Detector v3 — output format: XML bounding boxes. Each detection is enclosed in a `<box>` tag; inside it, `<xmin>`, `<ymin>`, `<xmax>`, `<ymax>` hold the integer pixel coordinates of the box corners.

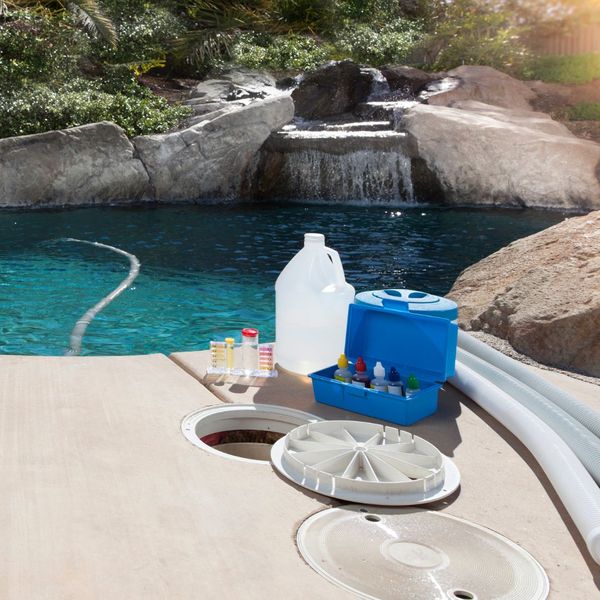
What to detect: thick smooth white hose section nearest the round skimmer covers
<box><xmin>449</xmin><ymin>361</ymin><xmax>600</xmax><ymax>564</ymax></box>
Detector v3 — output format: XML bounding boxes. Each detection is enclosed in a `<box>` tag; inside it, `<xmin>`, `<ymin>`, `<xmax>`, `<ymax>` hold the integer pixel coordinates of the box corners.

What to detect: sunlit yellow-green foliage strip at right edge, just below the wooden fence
<box><xmin>522</xmin><ymin>54</ymin><xmax>600</xmax><ymax>84</ymax></box>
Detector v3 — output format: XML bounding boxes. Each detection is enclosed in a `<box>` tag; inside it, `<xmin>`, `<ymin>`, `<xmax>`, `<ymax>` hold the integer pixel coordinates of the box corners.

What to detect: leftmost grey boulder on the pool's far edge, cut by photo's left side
<box><xmin>0</xmin><ymin>122</ymin><xmax>148</xmax><ymax>207</ymax></box>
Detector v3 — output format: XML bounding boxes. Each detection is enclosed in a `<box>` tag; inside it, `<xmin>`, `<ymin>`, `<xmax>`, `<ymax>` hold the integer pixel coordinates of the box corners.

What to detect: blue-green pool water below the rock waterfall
<box><xmin>0</xmin><ymin>205</ymin><xmax>564</xmax><ymax>355</ymax></box>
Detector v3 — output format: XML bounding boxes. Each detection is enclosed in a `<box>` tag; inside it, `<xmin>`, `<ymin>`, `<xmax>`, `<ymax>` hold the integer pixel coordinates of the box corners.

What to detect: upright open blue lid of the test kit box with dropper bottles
<box><xmin>345</xmin><ymin>303</ymin><xmax>458</xmax><ymax>382</ymax></box>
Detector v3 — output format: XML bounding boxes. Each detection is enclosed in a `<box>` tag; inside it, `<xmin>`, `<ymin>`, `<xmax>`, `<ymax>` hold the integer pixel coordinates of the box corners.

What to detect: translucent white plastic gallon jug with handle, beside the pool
<box><xmin>275</xmin><ymin>233</ymin><xmax>354</xmax><ymax>375</ymax></box>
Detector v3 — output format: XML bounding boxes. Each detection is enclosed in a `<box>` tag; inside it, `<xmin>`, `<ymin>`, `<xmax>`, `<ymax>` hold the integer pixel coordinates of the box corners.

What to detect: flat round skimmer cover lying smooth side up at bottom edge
<box><xmin>297</xmin><ymin>505</ymin><xmax>549</xmax><ymax>600</ymax></box>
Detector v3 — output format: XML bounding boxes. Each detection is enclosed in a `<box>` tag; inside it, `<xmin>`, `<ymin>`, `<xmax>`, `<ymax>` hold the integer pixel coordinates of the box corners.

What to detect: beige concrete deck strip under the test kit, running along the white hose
<box><xmin>171</xmin><ymin>352</ymin><xmax>600</xmax><ymax>600</ymax></box>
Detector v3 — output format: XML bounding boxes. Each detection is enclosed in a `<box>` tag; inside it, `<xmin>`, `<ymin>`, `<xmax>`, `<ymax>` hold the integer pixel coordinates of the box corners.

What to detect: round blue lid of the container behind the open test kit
<box><xmin>355</xmin><ymin>289</ymin><xmax>458</xmax><ymax>321</ymax></box>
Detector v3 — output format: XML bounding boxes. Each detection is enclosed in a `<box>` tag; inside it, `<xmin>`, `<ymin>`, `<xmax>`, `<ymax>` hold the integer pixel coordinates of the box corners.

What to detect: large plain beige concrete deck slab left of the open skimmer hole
<box><xmin>0</xmin><ymin>355</ymin><xmax>349</xmax><ymax>600</ymax></box>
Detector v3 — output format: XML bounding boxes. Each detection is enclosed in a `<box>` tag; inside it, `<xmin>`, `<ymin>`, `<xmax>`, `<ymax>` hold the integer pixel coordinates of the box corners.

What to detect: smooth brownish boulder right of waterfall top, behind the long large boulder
<box><xmin>421</xmin><ymin>65</ymin><xmax>536</xmax><ymax>110</ymax></box>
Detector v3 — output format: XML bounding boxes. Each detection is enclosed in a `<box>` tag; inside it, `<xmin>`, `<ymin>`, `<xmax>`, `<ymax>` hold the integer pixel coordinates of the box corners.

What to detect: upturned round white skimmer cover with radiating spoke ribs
<box><xmin>271</xmin><ymin>421</ymin><xmax>460</xmax><ymax>506</ymax></box>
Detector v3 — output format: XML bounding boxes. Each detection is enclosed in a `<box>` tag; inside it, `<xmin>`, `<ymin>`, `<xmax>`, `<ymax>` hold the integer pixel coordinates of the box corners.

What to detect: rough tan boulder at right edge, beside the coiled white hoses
<box><xmin>448</xmin><ymin>211</ymin><xmax>600</xmax><ymax>377</ymax></box>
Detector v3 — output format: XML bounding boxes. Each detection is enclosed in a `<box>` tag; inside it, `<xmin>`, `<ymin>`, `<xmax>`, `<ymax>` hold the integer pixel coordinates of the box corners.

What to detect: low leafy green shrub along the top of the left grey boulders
<box><xmin>0</xmin><ymin>79</ymin><xmax>191</xmax><ymax>137</ymax></box>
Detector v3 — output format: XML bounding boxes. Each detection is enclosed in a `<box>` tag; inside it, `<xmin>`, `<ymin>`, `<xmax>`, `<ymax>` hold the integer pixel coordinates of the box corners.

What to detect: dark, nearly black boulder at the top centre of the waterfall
<box><xmin>292</xmin><ymin>60</ymin><xmax>373</xmax><ymax>119</ymax></box>
